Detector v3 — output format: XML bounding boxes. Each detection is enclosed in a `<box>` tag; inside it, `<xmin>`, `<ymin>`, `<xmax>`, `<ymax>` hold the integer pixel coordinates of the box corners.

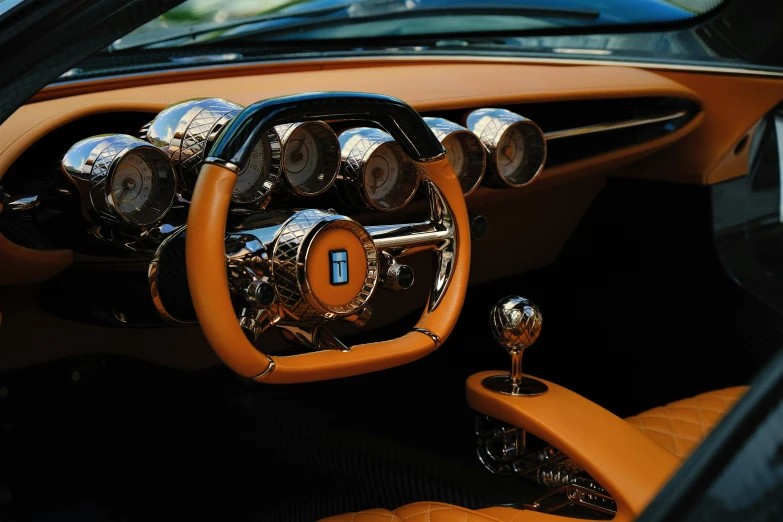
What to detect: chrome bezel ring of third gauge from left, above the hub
<box><xmin>275</xmin><ymin>121</ymin><xmax>340</xmax><ymax>196</ymax></box>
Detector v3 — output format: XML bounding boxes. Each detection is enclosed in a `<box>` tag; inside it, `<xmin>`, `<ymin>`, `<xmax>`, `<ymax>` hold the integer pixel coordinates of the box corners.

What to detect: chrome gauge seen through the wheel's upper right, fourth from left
<box><xmin>339</xmin><ymin>127</ymin><xmax>419</xmax><ymax>212</ymax></box>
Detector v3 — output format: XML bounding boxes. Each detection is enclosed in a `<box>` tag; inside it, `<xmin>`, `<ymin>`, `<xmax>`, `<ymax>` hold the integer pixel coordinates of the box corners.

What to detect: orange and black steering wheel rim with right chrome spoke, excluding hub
<box><xmin>186</xmin><ymin>93</ymin><xmax>470</xmax><ymax>383</ymax></box>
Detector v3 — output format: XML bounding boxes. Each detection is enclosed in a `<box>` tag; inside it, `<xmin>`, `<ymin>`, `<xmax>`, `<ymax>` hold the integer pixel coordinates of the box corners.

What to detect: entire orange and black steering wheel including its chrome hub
<box><xmin>186</xmin><ymin>93</ymin><xmax>470</xmax><ymax>383</ymax></box>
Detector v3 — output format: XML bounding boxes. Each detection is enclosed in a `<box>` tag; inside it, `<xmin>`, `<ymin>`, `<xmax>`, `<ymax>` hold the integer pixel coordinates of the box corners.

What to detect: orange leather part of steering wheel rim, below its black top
<box><xmin>186</xmin><ymin>158</ymin><xmax>470</xmax><ymax>383</ymax></box>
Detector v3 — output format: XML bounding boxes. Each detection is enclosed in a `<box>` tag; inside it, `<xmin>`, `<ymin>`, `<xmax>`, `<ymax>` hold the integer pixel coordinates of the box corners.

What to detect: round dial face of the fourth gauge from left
<box><xmin>363</xmin><ymin>142</ymin><xmax>418</xmax><ymax>210</ymax></box>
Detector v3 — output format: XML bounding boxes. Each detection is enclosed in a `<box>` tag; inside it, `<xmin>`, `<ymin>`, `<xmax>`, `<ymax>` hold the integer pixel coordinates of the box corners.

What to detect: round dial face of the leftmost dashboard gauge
<box><xmin>111</xmin><ymin>152</ymin><xmax>156</xmax><ymax>218</ymax></box>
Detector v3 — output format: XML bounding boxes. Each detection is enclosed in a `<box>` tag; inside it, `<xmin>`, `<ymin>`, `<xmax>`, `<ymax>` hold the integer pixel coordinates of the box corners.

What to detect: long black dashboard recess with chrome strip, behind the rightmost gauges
<box><xmin>425</xmin><ymin>97</ymin><xmax>701</xmax><ymax>167</ymax></box>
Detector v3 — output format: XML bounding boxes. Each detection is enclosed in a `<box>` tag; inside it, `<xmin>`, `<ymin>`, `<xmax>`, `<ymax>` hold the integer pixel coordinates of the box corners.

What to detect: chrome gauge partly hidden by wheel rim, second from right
<box><xmin>424</xmin><ymin>118</ymin><xmax>487</xmax><ymax>196</ymax></box>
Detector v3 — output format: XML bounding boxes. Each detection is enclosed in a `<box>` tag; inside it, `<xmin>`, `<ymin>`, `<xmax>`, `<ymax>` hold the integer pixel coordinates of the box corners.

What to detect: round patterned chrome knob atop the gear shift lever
<box><xmin>489</xmin><ymin>295</ymin><xmax>542</xmax><ymax>354</ymax></box>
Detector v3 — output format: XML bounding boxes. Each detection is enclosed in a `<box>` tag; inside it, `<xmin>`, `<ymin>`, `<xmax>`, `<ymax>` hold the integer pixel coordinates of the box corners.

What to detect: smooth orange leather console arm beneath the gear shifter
<box><xmin>466</xmin><ymin>372</ymin><xmax>681</xmax><ymax>522</ymax></box>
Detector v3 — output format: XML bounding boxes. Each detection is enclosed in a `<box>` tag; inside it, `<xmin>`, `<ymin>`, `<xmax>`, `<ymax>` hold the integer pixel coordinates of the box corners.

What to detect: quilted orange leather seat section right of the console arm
<box><xmin>626</xmin><ymin>386</ymin><xmax>748</xmax><ymax>459</ymax></box>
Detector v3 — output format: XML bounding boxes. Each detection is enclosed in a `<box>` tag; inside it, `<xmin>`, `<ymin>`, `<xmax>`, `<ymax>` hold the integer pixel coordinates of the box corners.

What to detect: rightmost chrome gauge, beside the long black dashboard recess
<box><xmin>467</xmin><ymin>109</ymin><xmax>546</xmax><ymax>188</ymax></box>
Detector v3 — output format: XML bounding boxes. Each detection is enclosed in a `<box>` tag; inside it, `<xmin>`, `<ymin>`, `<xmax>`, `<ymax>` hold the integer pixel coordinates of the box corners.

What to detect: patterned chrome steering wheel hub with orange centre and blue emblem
<box><xmin>272</xmin><ymin>210</ymin><xmax>378</xmax><ymax>321</ymax></box>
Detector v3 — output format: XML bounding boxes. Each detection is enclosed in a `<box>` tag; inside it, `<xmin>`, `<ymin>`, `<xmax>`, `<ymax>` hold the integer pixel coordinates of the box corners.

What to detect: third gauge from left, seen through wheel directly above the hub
<box><xmin>275</xmin><ymin>121</ymin><xmax>340</xmax><ymax>196</ymax></box>
